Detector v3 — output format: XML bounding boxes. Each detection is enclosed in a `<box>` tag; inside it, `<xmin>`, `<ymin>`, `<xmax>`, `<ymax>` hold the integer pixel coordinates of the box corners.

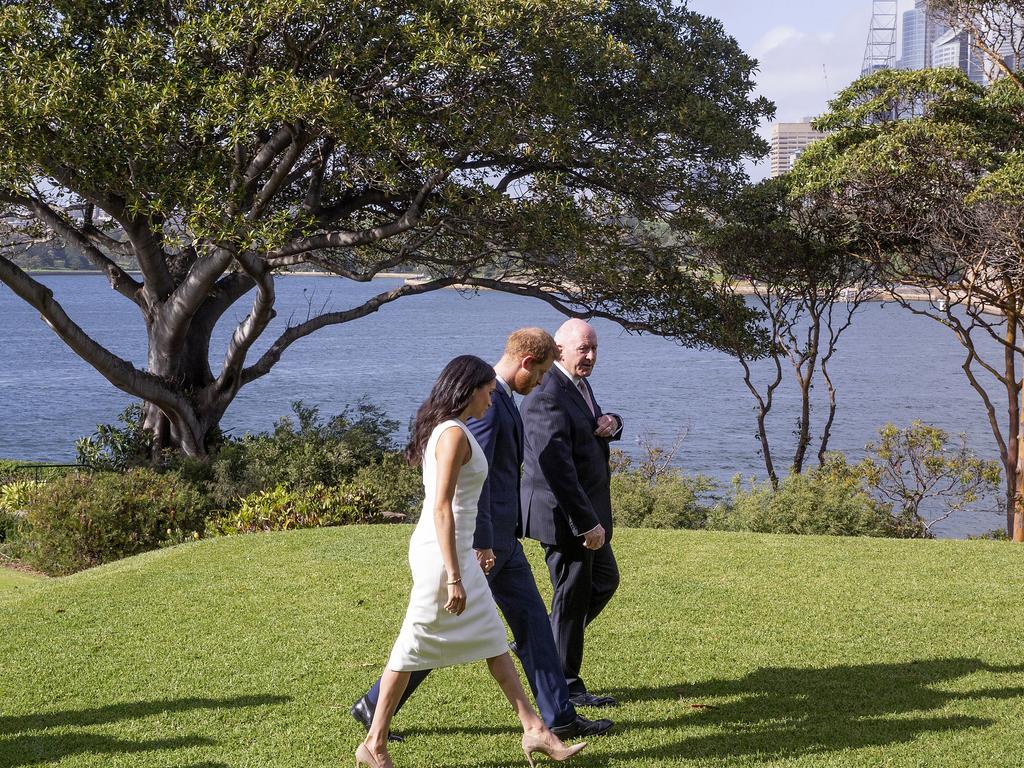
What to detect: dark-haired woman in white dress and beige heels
<box><xmin>355</xmin><ymin>355</ymin><xmax>586</xmax><ymax>768</ymax></box>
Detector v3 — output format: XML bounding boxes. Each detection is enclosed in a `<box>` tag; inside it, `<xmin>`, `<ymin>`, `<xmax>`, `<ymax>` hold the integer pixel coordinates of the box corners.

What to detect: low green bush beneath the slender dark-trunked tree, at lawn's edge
<box><xmin>708</xmin><ymin>457</ymin><xmax>901</xmax><ymax>537</ymax></box>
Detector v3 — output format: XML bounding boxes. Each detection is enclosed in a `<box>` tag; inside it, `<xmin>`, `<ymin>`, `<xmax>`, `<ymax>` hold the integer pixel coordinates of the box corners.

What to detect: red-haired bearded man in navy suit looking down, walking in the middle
<box><xmin>351</xmin><ymin>328</ymin><xmax>612</xmax><ymax>739</ymax></box>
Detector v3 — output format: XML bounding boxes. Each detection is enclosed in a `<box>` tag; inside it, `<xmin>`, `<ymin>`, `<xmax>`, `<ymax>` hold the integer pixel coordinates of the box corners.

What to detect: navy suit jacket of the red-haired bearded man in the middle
<box><xmin>466</xmin><ymin>384</ymin><xmax>522</xmax><ymax>550</ymax></box>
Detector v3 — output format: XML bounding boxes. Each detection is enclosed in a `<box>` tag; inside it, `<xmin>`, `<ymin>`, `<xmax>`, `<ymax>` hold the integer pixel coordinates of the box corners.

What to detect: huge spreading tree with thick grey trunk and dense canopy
<box><xmin>0</xmin><ymin>0</ymin><xmax>771</xmax><ymax>455</ymax></box>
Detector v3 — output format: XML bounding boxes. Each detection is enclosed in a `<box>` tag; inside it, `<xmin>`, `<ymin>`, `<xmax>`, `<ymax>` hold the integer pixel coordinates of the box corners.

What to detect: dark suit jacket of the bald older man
<box><xmin>522</xmin><ymin>368</ymin><xmax>622</xmax><ymax>546</ymax></box>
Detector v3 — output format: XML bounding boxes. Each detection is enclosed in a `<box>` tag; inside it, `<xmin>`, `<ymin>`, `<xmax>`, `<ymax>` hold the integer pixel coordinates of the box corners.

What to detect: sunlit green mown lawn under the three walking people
<box><xmin>0</xmin><ymin>526</ymin><xmax>1024</xmax><ymax>768</ymax></box>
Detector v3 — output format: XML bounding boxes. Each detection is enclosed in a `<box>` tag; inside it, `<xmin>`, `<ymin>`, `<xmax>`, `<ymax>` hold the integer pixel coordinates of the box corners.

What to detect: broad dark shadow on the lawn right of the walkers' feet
<box><xmin>466</xmin><ymin>658</ymin><xmax>1024</xmax><ymax>765</ymax></box>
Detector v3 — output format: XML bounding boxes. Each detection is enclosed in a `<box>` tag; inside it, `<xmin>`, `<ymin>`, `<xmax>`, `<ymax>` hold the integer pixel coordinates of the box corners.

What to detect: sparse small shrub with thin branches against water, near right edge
<box><xmin>855</xmin><ymin>421</ymin><xmax>1002</xmax><ymax>532</ymax></box>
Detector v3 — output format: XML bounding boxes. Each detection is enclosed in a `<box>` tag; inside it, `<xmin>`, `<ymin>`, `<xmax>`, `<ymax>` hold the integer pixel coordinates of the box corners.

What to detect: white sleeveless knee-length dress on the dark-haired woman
<box><xmin>387</xmin><ymin>419</ymin><xmax>509</xmax><ymax>672</ymax></box>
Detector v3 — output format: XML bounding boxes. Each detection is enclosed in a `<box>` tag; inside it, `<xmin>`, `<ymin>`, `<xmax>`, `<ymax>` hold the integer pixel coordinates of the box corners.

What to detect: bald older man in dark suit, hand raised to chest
<box><xmin>522</xmin><ymin>319</ymin><xmax>623</xmax><ymax>707</ymax></box>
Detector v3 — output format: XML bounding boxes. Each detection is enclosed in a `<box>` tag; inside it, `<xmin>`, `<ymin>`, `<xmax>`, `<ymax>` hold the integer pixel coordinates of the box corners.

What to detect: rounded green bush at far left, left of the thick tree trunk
<box><xmin>17</xmin><ymin>469</ymin><xmax>206</xmax><ymax>575</ymax></box>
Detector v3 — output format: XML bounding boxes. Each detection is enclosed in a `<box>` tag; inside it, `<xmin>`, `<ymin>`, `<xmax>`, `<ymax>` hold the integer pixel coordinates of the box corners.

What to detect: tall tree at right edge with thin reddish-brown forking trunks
<box><xmin>793</xmin><ymin>70</ymin><xmax>1024</xmax><ymax>541</ymax></box>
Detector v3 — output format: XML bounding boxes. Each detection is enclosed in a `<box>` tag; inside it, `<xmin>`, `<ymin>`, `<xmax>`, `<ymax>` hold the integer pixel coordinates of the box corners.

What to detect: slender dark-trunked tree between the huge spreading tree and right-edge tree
<box><xmin>694</xmin><ymin>176</ymin><xmax>876</xmax><ymax>486</ymax></box>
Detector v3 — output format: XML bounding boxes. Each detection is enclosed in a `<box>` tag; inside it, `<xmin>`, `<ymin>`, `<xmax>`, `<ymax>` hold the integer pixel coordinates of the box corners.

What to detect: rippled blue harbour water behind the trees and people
<box><xmin>0</xmin><ymin>274</ymin><xmax>1005</xmax><ymax>537</ymax></box>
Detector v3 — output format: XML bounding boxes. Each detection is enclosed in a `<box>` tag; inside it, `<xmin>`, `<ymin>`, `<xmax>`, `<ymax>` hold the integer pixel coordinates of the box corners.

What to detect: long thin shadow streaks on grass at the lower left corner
<box><xmin>0</xmin><ymin>695</ymin><xmax>291</xmax><ymax>768</ymax></box>
